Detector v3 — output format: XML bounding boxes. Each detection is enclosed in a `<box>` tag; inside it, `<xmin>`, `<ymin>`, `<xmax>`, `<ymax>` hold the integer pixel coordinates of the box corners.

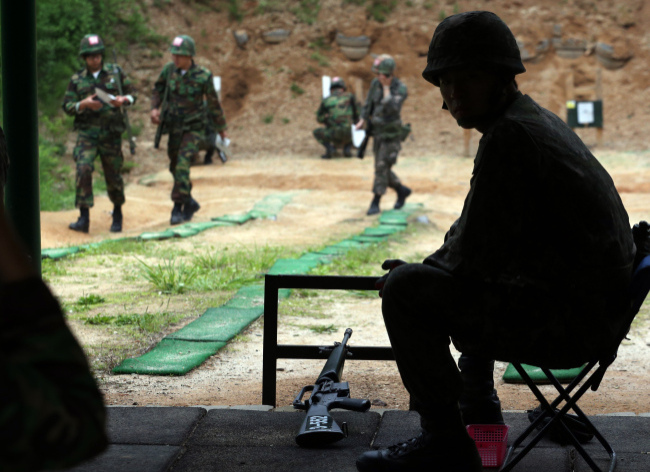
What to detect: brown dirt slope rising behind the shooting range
<box><xmin>110</xmin><ymin>0</ymin><xmax>650</xmax><ymax>175</ymax></box>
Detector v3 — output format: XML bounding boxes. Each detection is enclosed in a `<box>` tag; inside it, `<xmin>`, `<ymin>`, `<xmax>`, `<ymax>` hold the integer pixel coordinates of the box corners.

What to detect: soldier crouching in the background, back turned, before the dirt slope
<box><xmin>314</xmin><ymin>77</ymin><xmax>359</xmax><ymax>159</ymax></box>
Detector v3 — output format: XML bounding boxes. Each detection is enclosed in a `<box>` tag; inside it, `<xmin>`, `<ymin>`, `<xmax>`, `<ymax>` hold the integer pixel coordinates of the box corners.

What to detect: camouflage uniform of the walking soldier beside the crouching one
<box><xmin>361</xmin><ymin>77</ymin><xmax>408</xmax><ymax>195</ymax></box>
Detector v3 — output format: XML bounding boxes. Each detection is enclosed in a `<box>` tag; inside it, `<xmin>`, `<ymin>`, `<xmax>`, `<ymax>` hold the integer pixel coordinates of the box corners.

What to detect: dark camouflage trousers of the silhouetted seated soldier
<box><xmin>382</xmin><ymin>264</ymin><xmax>629</xmax><ymax>421</ymax></box>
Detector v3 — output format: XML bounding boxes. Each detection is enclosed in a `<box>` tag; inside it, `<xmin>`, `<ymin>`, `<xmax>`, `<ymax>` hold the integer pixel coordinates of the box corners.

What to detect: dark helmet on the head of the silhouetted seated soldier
<box><xmin>422</xmin><ymin>11</ymin><xmax>526</xmax><ymax>87</ymax></box>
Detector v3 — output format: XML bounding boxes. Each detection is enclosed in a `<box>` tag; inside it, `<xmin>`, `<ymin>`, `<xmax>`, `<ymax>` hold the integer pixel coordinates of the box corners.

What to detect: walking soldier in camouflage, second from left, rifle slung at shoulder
<box><xmin>151</xmin><ymin>35</ymin><xmax>227</xmax><ymax>225</ymax></box>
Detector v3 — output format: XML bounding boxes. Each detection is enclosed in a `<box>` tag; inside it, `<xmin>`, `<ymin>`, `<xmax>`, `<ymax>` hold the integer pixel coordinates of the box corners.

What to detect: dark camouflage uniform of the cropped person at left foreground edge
<box><xmin>0</xmin><ymin>277</ymin><xmax>108</xmax><ymax>471</ymax></box>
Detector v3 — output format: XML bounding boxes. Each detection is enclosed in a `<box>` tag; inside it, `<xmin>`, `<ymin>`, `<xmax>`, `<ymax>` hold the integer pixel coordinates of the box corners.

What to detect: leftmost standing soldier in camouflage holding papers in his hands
<box><xmin>63</xmin><ymin>34</ymin><xmax>136</xmax><ymax>233</ymax></box>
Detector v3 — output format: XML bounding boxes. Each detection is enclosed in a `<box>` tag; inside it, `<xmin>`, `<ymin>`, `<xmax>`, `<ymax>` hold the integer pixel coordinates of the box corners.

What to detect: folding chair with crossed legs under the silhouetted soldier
<box><xmin>500</xmin><ymin>256</ymin><xmax>650</xmax><ymax>472</ymax></box>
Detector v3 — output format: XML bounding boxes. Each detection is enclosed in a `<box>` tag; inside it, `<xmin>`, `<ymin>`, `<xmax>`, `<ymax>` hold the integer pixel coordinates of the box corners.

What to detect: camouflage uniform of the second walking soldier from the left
<box><xmin>151</xmin><ymin>62</ymin><xmax>226</xmax><ymax>203</ymax></box>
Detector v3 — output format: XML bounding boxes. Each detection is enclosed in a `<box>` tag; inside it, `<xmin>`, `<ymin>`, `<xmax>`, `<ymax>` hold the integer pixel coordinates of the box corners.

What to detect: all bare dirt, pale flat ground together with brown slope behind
<box><xmin>41</xmin><ymin>0</ymin><xmax>650</xmax><ymax>413</ymax></box>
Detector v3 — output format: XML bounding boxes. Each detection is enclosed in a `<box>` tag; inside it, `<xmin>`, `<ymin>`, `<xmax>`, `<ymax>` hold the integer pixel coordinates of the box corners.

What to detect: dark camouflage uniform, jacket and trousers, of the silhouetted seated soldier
<box><xmin>383</xmin><ymin>93</ymin><xmax>635</xmax><ymax>419</ymax></box>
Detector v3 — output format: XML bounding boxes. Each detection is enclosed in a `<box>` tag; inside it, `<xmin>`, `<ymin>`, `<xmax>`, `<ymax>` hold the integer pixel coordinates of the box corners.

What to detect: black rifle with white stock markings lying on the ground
<box><xmin>293</xmin><ymin>328</ymin><xmax>370</xmax><ymax>447</ymax></box>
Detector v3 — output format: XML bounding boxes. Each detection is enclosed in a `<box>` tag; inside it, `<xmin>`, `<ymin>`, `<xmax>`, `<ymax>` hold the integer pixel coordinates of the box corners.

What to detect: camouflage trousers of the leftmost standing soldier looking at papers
<box><xmin>73</xmin><ymin>127</ymin><xmax>124</xmax><ymax>208</ymax></box>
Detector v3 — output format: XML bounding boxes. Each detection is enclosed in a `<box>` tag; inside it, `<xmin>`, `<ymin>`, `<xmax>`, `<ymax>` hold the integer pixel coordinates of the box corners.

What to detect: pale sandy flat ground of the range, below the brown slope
<box><xmin>42</xmin><ymin>149</ymin><xmax>650</xmax><ymax>412</ymax></box>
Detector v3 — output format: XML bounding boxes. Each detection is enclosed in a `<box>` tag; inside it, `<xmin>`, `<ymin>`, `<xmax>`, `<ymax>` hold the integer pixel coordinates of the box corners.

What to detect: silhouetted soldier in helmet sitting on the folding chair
<box><xmin>357</xmin><ymin>11</ymin><xmax>635</xmax><ymax>472</ymax></box>
